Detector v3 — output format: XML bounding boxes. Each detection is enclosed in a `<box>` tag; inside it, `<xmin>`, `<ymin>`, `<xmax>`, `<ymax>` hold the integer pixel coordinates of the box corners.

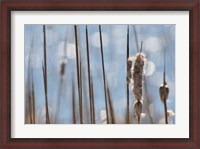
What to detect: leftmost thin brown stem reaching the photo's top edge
<box><xmin>43</xmin><ymin>25</ymin><xmax>50</xmax><ymax>124</ymax></box>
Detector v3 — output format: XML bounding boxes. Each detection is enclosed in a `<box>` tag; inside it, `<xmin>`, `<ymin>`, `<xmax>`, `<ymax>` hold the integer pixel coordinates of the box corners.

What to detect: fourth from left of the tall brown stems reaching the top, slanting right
<box><xmin>99</xmin><ymin>25</ymin><xmax>109</xmax><ymax>124</ymax></box>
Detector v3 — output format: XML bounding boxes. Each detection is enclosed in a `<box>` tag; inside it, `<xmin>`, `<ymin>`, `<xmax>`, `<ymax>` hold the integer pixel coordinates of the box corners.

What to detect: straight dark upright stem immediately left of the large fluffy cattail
<box><xmin>126</xmin><ymin>25</ymin><xmax>130</xmax><ymax>124</ymax></box>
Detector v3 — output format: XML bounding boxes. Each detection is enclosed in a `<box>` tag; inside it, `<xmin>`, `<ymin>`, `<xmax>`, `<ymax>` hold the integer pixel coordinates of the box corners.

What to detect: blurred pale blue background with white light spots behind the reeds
<box><xmin>24</xmin><ymin>24</ymin><xmax>175</xmax><ymax>124</ymax></box>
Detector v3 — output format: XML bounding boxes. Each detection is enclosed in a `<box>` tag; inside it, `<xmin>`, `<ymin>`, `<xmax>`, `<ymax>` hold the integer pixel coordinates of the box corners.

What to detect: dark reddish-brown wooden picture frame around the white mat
<box><xmin>0</xmin><ymin>0</ymin><xmax>200</xmax><ymax>149</ymax></box>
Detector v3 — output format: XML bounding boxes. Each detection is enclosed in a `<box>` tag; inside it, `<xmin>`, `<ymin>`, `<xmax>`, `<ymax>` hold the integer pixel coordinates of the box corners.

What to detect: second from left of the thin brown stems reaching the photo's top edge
<box><xmin>74</xmin><ymin>25</ymin><xmax>83</xmax><ymax>124</ymax></box>
